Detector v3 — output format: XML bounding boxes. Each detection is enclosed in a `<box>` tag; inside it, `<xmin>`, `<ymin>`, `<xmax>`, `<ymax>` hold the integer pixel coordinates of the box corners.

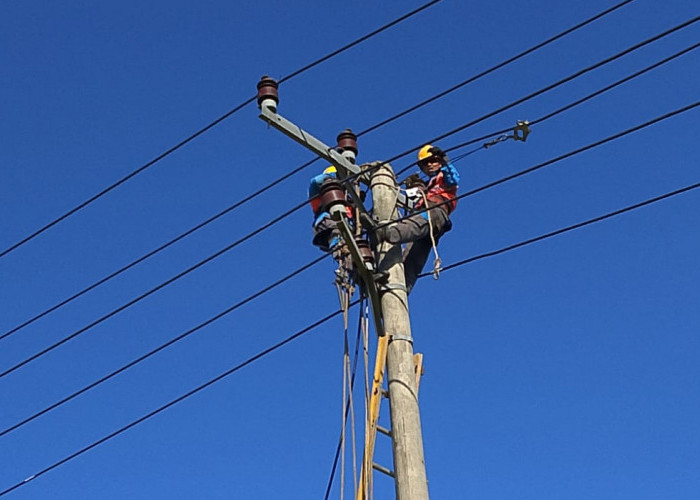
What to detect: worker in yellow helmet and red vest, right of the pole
<box><xmin>374</xmin><ymin>144</ymin><xmax>459</xmax><ymax>293</ymax></box>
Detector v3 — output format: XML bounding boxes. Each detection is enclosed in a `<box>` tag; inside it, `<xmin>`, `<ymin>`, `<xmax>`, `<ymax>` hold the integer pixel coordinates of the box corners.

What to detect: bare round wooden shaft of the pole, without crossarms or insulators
<box><xmin>370</xmin><ymin>164</ymin><xmax>428</xmax><ymax>500</ymax></box>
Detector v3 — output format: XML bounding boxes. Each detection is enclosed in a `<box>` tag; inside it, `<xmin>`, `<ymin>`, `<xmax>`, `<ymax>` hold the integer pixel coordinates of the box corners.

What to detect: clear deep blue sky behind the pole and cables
<box><xmin>0</xmin><ymin>0</ymin><xmax>700</xmax><ymax>500</ymax></box>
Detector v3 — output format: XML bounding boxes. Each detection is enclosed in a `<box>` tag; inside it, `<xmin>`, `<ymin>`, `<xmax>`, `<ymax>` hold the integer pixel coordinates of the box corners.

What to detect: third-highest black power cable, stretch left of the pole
<box><xmin>0</xmin><ymin>201</ymin><xmax>308</xmax><ymax>378</ymax></box>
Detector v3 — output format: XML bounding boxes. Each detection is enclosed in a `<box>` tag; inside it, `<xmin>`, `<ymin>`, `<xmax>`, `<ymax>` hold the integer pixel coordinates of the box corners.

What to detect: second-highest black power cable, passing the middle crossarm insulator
<box><xmin>0</xmin><ymin>0</ymin><xmax>634</xmax><ymax>340</ymax></box>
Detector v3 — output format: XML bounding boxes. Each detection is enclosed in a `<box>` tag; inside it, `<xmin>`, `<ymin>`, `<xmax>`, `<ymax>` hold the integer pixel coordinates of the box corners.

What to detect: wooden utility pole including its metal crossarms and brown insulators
<box><xmin>258</xmin><ymin>76</ymin><xmax>428</xmax><ymax>500</ymax></box>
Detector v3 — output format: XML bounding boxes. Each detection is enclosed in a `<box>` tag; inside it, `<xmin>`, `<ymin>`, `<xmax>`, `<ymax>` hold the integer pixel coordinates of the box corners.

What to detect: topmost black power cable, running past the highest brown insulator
<box><xmin>0</xmin><ymin>0</ymin><xmax>440</xmax><ymax>258</ymax></box>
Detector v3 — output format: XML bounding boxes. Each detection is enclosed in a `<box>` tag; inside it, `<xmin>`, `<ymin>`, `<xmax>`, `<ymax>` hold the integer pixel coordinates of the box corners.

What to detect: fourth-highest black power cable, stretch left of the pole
<box><xmin>0</xmin><ymin>254</ymin><xmax>330</xmax><ymax>437</ymax></box>
